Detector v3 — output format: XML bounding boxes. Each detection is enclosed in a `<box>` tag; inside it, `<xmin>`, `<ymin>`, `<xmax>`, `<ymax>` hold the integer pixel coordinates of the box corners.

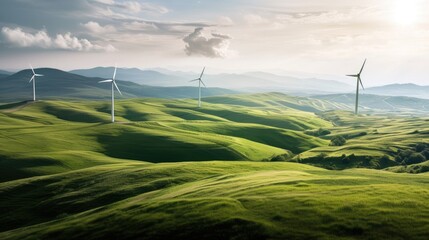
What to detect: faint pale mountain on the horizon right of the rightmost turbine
<box><xmin>364</xmin><ymin>83</ymin><xmax>429</xmax><ymax>99</ymax></box>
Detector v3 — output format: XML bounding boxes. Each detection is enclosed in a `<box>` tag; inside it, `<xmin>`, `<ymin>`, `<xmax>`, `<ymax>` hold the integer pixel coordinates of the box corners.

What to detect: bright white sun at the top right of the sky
<box><xmin>393</xmin><ymin>0</ymin><xmax>418</xmax><ymax>26</ymax></box>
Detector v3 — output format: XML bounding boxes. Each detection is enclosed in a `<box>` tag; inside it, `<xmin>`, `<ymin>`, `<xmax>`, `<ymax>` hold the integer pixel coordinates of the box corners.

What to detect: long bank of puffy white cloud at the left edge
<box><xmin>1</xmin><ymin>27</ymin><xmax>116</xmax><ymax>52</ymax></box>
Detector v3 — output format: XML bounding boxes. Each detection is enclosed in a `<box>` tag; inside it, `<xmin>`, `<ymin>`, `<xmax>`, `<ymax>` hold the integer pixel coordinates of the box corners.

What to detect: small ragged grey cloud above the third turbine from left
<box><xmin>183</xmin><ymin>28</ymin><xmax>231</xmax><ymax>58</ymax></box>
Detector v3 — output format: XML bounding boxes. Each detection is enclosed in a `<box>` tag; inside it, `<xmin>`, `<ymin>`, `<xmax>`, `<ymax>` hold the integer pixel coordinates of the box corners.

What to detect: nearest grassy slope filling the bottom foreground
<box><xmin>0</xmin><ymin>162</ymin><xmax>429</xmax><ymax>239</ymax></box>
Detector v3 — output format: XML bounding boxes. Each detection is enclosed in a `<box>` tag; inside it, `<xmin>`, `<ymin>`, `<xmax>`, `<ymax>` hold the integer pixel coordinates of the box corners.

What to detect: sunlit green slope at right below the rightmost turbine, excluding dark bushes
<box><xmin>299</xmin><ymin>111</ymin><xmax>429</xmax><ymax>168</ymax></box>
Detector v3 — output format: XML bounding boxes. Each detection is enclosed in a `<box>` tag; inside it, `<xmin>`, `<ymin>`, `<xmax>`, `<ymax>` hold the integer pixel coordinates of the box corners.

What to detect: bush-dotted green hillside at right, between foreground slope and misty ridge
<box><xmin>294</xmin><ymin>111</ymin><xmax>429</xmax><ymax>169</ymax></box>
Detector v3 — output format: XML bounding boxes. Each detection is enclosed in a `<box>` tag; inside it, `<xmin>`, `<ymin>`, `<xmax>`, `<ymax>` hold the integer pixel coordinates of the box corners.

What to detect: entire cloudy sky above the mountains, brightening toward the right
<box><xmin>0</xmin><ymin>0</ymin><xmax>429</xmax><ymax>86</ymax></box>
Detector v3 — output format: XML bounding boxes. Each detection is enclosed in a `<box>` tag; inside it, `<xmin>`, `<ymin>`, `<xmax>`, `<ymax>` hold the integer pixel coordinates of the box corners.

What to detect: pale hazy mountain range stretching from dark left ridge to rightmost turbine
<box><xmin>71</xmin><ymin>67</ymin><xmax>353</xmax><ymax>95</ymax></box>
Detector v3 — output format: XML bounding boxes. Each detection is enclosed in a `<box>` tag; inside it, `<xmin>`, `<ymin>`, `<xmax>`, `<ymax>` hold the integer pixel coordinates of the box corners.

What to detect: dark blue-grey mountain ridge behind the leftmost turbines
<box><xmin>0</xmin><ymin>68</ymin><xmax>236</xmax><ymax>102</ymax></box>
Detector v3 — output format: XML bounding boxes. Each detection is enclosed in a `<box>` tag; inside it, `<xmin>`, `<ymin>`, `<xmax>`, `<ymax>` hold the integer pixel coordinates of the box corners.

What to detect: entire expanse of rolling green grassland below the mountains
<box><xmin>0</xmin><ymin>94</ymin><xmax>429</xmax><ymax>239</ymax></box>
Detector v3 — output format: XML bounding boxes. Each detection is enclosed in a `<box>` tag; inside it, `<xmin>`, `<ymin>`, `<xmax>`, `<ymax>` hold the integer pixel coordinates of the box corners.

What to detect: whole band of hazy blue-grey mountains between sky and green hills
<box><xmin>0</xmin><ymin>67</ymin><xmax>429</xmax><ymax>113</ymax></box>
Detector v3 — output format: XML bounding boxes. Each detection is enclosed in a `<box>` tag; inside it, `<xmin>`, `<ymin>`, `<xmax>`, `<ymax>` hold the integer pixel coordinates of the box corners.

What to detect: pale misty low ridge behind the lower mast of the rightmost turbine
<box><xmin>312</xmin><ymin>94</ymin><xmax>429</xmax><ymax>114</ymax></box>
